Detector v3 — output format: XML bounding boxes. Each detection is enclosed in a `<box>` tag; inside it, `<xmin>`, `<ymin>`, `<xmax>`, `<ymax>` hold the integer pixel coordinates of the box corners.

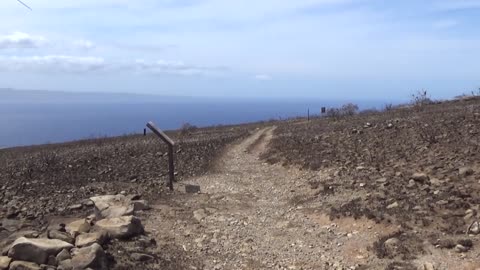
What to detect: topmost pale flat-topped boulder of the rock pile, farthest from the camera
<box><xmin>90</xmin><ymin>194</ymin><xmax>134</xmax><ymax>219</ymax></box>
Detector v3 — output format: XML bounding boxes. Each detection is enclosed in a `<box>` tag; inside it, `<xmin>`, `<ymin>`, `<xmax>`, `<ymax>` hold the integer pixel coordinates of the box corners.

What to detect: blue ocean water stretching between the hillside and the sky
<box><xmin>0</xmin><ymin>100</ymin><xmax>385</xmax><ymax>148</ymax></box>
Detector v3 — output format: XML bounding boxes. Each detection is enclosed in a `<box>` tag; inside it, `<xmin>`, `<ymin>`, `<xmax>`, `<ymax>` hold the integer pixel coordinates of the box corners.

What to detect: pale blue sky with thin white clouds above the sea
<box><xmin>0</xmin><ymin>0</ymin><xmax>480</xmax><ymax>100</ymax></box>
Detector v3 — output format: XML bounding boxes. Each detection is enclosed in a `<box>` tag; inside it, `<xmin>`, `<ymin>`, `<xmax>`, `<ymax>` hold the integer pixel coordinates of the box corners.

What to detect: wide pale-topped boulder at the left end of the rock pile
<box><xmin>8</xmin><ymin>237</ymin><xmax>73</xmax><ymax>264</ymax></box>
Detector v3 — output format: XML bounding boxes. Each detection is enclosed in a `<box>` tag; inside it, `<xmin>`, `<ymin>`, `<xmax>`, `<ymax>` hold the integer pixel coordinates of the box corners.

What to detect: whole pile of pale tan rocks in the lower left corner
<box><xmin>0</xmin><ymin>195</ymin><xmax>149</xmax><ymax>270</ymax></box>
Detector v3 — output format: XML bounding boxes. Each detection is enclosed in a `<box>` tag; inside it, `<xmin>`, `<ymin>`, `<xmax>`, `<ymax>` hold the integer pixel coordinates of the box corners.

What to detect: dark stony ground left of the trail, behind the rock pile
<box><xmin>0</xmin><ymin>126</ymin><xmax>251</xmax><ymax>240</ymax></box>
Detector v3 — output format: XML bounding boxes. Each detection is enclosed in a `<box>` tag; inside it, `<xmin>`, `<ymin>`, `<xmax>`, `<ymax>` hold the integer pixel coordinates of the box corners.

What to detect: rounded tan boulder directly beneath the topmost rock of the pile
<box><xmin>95</xmin><ymin>216</ymin><xmax>144</xmax><ymax>239</ymax></box>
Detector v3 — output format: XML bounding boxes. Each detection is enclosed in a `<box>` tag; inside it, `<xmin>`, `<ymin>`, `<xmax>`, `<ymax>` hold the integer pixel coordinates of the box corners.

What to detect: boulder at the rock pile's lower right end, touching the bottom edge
<box><xmin>72</xmin><ymin>243</ymin><xmax>108</xmax><ymax>270</ymax></box>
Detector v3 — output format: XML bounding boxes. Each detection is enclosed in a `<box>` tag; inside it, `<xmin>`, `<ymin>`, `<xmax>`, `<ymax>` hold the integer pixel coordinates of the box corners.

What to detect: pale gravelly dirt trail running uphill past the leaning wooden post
<box><xmin>142</xmin><ymin>127</ymin><xmax>408</xmax><ymax>269</ymax></box>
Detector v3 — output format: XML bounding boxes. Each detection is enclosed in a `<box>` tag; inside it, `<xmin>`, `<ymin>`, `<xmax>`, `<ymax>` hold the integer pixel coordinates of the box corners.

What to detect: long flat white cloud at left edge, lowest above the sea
<box><xmin>0</xmin><ymin>55</ymin><xmax>107</xmax><ymax>73</ymax></box>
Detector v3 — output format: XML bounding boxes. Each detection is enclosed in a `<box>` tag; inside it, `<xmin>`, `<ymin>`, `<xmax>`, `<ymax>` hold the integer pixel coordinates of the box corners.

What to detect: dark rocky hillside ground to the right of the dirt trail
<box><xmin>262</xmin><ymin>98</ymin><xmax>480</xmax><ymax>269</ymax></box>
